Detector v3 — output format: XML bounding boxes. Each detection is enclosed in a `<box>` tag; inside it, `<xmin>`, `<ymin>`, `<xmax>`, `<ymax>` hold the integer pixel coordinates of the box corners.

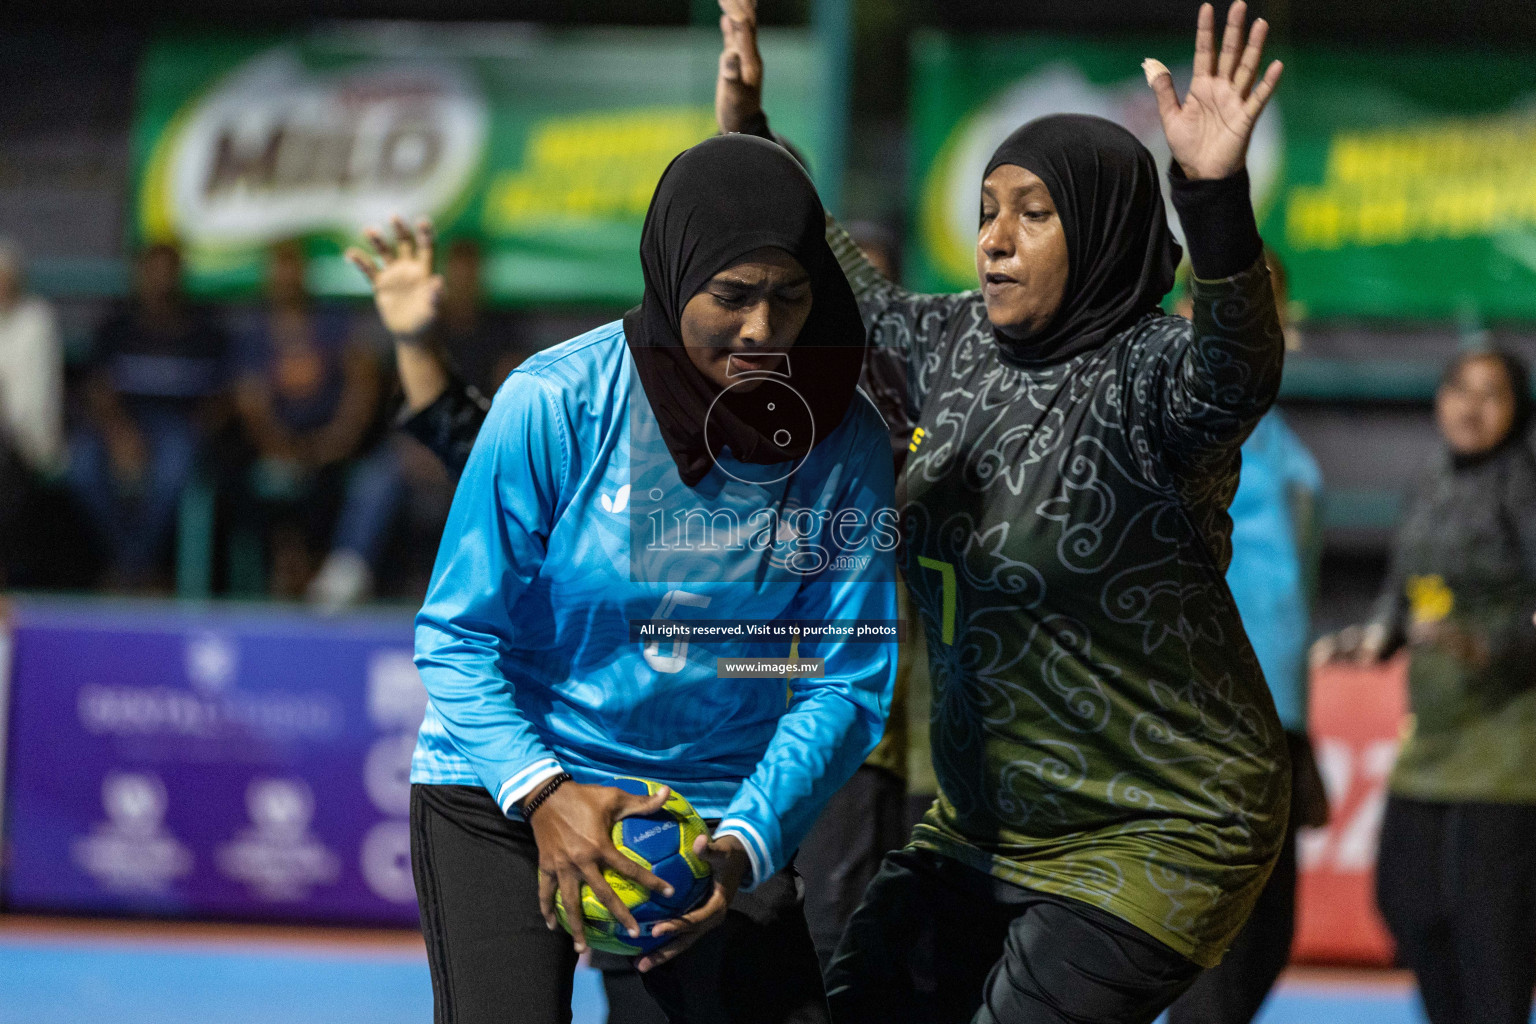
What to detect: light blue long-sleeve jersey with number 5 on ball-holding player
<box><xmin>410</xmin><ymin>322</ymin><xmax>895</xmax><ymax>884</ymax></box>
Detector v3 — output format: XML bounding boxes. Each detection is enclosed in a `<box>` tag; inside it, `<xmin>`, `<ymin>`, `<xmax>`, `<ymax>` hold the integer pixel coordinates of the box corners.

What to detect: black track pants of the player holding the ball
<box><xmin>410</xmin><ymin>785</ymin><xmax>828</xmax><ymax>1024</ymax></box>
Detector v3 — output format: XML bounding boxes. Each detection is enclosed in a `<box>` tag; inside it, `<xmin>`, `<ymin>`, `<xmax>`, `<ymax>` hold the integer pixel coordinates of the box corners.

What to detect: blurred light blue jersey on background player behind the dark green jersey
<box><xmin>1227</xmin><ymin>410</ymin><xmax>1322</xmax><ymax>731</ymax></box>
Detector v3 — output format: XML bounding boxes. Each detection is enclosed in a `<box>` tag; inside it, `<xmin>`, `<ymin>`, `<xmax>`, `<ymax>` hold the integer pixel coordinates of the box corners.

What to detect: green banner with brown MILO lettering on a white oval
<box><xmin>132</xmin><ymin>25</ymin><xmax>828</xmax><ymax>304</ymax></box>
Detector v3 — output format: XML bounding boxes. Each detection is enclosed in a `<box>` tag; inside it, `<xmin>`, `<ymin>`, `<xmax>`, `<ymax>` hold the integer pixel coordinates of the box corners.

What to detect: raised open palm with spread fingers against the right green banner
<box><xmin>1141</xmin><ymin>0</ymin><xmax>1283</xmax><ymax>178</ymax></box>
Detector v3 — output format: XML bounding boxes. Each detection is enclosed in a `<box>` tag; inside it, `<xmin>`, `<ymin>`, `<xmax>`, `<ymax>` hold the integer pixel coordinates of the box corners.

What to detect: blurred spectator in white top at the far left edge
<box><xmin>0</xmin><ymin>239</ymin><xmax>65</xmax><ymax>586</ymax></box>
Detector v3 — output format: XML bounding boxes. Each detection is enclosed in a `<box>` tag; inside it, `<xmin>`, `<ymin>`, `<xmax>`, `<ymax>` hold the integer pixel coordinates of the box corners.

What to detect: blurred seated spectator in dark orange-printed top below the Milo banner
<box><xmin>237</xmin><ymin>241</ymin><xmax>398</xmax><ymax>597</ymax></box>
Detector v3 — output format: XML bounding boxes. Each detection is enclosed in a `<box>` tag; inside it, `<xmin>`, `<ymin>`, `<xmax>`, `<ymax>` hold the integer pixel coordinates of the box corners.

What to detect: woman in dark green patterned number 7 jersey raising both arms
<box><xmin>717</xmin><ymin>0</ymin><xmax>1289</xmax><ymax>1024</ymax></box>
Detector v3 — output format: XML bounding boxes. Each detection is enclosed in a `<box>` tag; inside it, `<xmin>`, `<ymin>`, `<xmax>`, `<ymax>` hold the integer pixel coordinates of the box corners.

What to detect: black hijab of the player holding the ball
<box><xmin>624</xmin><ymin>135</ymin><xmax>865</xmax><ymax>487</ymax></box>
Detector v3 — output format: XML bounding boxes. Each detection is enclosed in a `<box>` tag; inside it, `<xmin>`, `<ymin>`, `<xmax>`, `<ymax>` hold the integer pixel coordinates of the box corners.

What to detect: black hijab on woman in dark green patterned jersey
<box><xmin>982</xmin><ymin>114</ymin><xmax>1183</xmax><ymax>364</ymax></box>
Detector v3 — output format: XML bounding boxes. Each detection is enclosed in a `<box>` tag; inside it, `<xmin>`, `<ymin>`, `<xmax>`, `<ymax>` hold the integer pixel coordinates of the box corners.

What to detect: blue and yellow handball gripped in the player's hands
<box><xmin>554</xmin><ymin>777</ymin><xmax>710</xmax><ymax>956</ymax></box>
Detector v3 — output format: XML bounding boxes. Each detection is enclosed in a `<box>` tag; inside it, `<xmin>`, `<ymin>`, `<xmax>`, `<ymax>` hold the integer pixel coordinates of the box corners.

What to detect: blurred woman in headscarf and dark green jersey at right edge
<box><xmin>1313</xmin><ymin>350</ymin><xmax>1536</xmax><ymax>1024</ymax></box>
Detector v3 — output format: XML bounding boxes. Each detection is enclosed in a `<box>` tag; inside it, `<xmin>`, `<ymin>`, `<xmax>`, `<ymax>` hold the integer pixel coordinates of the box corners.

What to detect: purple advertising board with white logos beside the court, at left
<box><xmin>0</xmin><ymin>602</ymin><xmax>427</xmax><ymax>926</ymax></box>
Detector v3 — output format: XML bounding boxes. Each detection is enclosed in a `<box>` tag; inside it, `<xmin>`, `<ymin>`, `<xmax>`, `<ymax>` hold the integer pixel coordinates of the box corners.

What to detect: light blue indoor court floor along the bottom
<box><xmin>0</xmin><ymin>917</ymin><xmax>1492</xmax><ymax>1024</ymax></box>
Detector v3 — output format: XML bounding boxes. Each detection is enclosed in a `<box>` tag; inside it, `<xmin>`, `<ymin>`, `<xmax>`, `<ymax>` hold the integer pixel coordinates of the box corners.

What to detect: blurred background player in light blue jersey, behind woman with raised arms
<box><xmin>1167</xmin><ymin>249</ymin><xmax>1327</xmax><ymax>1024</ymax></box>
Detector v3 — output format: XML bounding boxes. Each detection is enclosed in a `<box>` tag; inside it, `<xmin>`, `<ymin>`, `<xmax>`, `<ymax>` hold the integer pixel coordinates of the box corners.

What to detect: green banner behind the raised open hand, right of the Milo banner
<box><xmin>903</xmin><ymin>34</ymin><xmax>1536</xmax><ymax>321</ymax></box>
